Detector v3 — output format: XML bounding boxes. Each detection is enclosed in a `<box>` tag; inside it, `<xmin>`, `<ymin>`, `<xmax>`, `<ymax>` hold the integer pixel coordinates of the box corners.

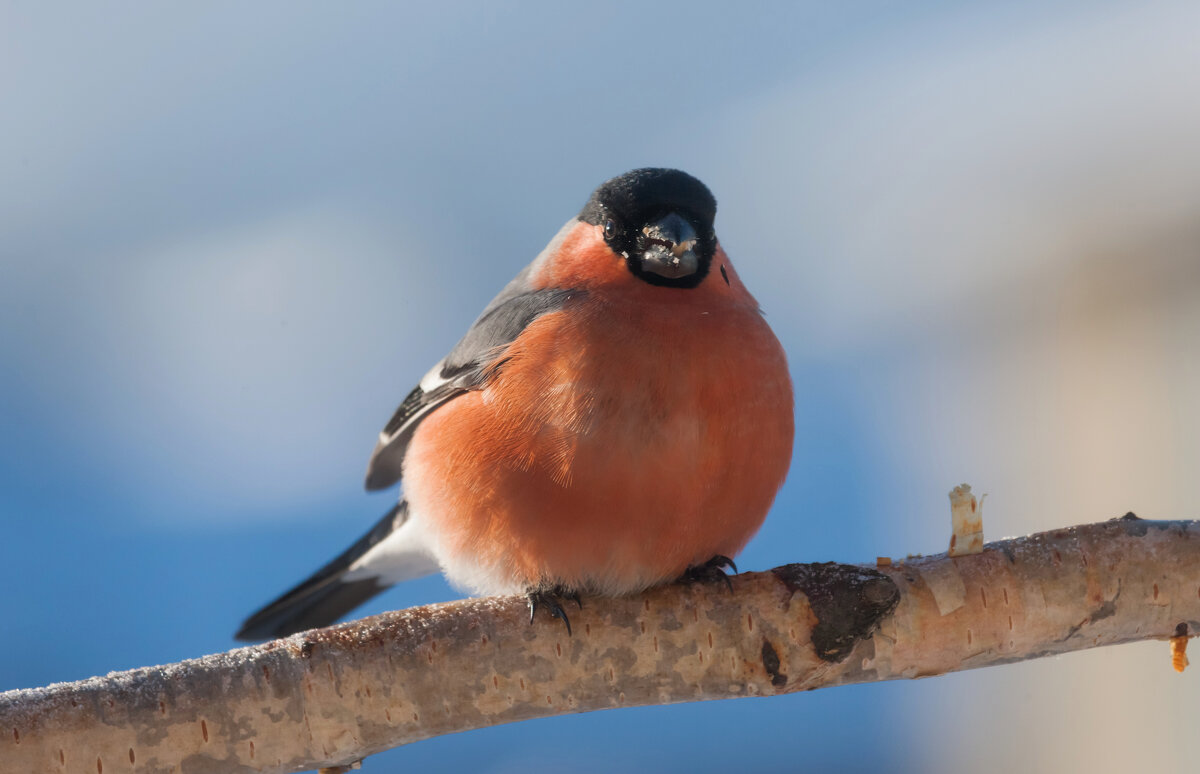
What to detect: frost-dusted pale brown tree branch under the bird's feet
<box><xmin>0</xmin><ymin>515</ymin><xmax>1200</xmax><ymax>774</ymax></box>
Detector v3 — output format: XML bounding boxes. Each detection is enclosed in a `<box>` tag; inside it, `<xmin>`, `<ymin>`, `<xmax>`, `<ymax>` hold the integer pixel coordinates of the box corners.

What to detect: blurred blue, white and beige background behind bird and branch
<box><xmin>0</xmin><ymin>0</ymin><xmax>1200</xmax><ymax>774</ymax></box>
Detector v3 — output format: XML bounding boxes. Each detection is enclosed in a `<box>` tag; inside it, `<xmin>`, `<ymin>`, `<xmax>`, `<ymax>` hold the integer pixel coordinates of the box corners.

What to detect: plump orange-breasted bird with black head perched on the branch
<box><xmin>235</xmin><ymin>168</ymin><xmax>794</xmax><ymax>641</ymax></box>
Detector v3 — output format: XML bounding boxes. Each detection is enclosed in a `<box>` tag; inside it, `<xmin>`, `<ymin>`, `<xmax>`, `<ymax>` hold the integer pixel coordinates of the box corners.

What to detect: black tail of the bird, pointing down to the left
<box><xmin>234</xmin><ymin>500</ymin><xmax>408</xmax><ymax>642</ymax></box>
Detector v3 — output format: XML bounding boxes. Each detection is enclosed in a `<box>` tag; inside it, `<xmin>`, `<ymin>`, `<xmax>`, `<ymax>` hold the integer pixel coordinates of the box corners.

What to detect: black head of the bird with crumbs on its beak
<box><xmin>580</xmin><ymin>168</ymin><xmax>716</xmax><ymax>288</ymax></box>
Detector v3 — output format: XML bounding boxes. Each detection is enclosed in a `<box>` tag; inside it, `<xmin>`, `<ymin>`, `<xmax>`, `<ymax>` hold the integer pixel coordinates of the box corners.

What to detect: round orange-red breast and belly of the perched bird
<box><xmin>404</xmin><ymin>254</ymin><xmax>792</xmax><ymax>594</ymax></box>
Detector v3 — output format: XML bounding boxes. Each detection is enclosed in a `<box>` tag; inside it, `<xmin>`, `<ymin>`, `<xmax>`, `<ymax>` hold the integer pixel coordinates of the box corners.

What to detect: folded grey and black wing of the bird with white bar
<box><xmin>366</xmin><ymin>262</ymin><xmax>582</xmax><ymax>492</ymax></box>
